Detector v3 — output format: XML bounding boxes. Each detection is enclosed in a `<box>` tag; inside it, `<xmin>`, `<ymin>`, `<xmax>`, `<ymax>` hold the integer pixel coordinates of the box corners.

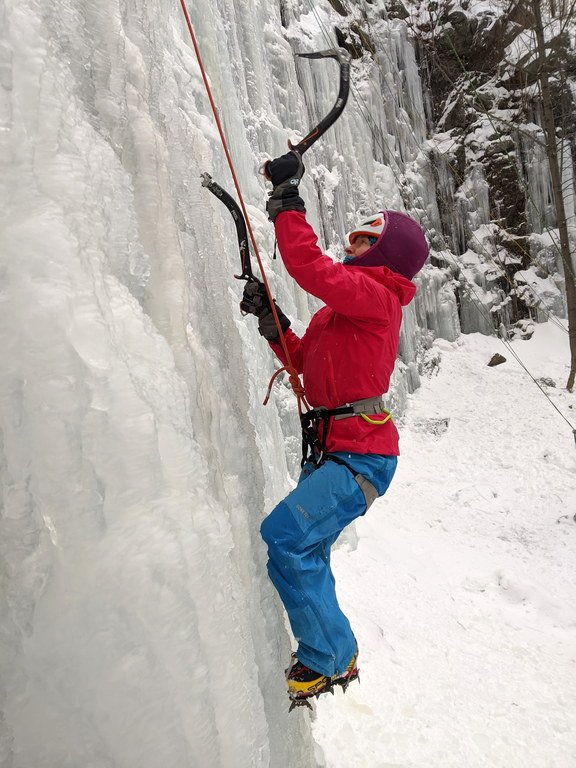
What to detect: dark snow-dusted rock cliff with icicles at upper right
<box><xmin>332</xmin><ymin>0</ymin><xmax>576</xmax><ymax>333</ymax></box>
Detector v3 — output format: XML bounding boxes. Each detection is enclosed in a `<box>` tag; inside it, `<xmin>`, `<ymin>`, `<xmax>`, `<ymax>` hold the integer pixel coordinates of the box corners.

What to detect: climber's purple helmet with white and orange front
<box><xmin>346</xmin><ymin>211</ymin><xmax>428</xmax><ymax>280</ymax></box>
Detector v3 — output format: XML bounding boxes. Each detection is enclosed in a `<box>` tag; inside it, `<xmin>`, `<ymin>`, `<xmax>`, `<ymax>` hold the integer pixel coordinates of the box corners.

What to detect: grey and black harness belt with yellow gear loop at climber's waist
<box><xmin>300</xmin><ymin>395</ymin><xmax>392</xmax><ymax>471</ymax></box>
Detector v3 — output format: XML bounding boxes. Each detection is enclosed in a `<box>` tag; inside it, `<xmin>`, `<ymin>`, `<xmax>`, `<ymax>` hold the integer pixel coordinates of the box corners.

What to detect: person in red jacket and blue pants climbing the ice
<box><xmin>241</xmin><ymin>151</ymin><xmax>428</xmax><ymax>705</ymax></box>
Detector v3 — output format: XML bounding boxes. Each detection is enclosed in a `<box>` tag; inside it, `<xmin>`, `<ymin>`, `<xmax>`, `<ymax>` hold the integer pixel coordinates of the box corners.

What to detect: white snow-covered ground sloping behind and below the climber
<box><xmin>312</xmin><ymin>324</ymin><xmax>576</xmax><ymax>768</ymax></box>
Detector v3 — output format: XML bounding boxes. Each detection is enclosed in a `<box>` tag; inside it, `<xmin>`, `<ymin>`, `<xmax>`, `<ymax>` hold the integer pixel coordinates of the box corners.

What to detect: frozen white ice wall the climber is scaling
<box><xmin>0</xmin><ymin>0</ymin><xmax>458</xmax><ymax>768</ymax></box>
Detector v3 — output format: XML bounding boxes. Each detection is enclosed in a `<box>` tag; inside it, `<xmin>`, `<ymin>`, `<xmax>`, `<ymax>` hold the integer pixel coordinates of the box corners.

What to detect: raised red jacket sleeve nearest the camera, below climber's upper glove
<box><xmin>275</xmin><ymin>211</ymin><xmax>398</xmax><ymax>325</ymax></box>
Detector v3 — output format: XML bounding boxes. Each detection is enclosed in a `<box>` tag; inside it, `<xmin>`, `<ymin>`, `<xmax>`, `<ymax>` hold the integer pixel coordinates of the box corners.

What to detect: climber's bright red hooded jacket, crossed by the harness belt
<box><xmin>270</xmin><ymin>211</ymin><xmax>416</xmax><ymax>456</ymax></box>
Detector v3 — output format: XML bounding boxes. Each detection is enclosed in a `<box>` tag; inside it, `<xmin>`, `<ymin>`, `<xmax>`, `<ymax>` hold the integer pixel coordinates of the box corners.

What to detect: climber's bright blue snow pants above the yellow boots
<box><xmin>260</xmin><ymin>451</ymin><xmax>397</xmax><ymax>677</ymax></box>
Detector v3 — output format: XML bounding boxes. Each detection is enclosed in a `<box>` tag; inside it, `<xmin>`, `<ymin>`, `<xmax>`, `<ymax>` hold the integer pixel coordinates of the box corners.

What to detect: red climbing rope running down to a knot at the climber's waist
<box><xmin>180</xmin><ymin>0</ymin><xmax>310</xmax><ymax>415</ymax></box>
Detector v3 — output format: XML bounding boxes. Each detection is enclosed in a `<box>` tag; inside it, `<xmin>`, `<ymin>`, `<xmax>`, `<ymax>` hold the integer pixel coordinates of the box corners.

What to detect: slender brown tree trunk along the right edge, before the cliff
<box><xmin>532</xmin><ymin>0</ymin><xmax>576</xmax><ymax>392</ymax></box>
